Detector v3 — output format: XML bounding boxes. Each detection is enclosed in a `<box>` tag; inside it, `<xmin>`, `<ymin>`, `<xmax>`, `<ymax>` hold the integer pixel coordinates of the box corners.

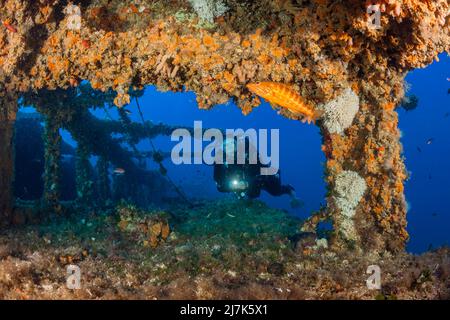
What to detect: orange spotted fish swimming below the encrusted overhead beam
<box><xmin>247</xmin><ymin>82</ymin><xmax>320</xmax><ymax>123</ymax></box>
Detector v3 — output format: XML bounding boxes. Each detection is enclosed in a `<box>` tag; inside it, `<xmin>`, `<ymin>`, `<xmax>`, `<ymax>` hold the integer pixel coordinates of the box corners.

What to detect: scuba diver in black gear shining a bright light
<box><xmin>214</xmin><ymin>138</ymin><xmax>301</xmax><ymax>208</ymax></box>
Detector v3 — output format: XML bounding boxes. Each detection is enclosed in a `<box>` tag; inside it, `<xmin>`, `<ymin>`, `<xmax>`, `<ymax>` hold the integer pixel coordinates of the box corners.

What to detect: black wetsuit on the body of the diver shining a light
<box><xmin>214</xmin><ymin>146</ymin><xmax>294</xmax><ymax>199</ymax></box>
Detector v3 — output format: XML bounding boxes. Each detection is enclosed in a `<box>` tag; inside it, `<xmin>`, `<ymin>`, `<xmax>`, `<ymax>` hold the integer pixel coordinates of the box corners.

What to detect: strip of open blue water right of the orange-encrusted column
<box><xmin>399</xmin><ymin>54</ymin><xmax>450</xmax><ymax>252</ymax></box>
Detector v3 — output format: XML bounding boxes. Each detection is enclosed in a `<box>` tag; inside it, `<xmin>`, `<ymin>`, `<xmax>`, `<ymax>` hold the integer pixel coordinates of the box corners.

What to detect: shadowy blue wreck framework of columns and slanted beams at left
<box><xmin>12</xmin><ymin>82</ymin><xmax>186</xmax><ymax>215</ymax></box>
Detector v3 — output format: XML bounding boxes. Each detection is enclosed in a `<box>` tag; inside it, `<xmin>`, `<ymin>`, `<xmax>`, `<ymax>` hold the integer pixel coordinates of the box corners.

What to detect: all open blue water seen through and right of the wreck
<box><xmin>32</xmin><ymin>54</ymin><xmax>450</xmax><ymax>253</ymax></box>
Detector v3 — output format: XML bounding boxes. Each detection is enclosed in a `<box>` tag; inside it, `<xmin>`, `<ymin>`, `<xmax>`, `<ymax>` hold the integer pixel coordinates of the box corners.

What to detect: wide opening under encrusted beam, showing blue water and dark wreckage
<box><xmin>11</xmin><ymin>82</ymin><xmax>326</xmax><ymax>222</ymax></box>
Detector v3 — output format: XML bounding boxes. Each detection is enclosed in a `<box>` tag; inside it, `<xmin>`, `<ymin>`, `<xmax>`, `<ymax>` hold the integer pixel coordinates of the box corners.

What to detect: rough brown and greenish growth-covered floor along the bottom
<box><xmin>0</xmin><ymin>200</ymin><xmax>450</xmax><ymax>299</ymax></box>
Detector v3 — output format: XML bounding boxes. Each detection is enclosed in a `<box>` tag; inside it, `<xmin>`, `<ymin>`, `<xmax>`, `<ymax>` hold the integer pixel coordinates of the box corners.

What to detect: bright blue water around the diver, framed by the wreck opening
<box><xmin>134</xmin><ymin>86</ymin><xmax>326</xmax><ymax>218</ymax></box>
